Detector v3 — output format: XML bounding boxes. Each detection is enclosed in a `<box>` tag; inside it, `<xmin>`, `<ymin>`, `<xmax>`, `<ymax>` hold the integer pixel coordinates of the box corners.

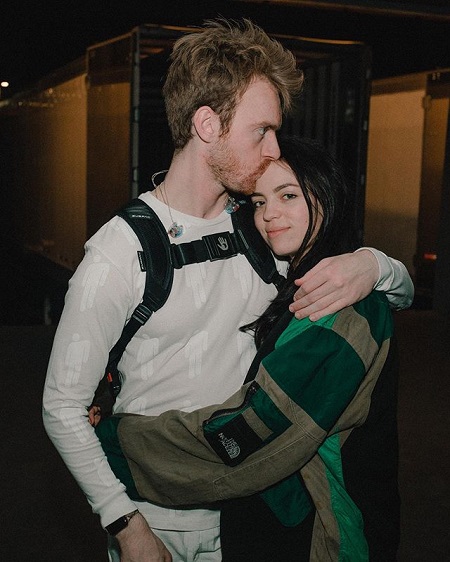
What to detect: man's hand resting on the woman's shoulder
<box><xmin>289</xmin><ymin>250</ymin><xmax>380</xmax><ymax>322</ymax></box>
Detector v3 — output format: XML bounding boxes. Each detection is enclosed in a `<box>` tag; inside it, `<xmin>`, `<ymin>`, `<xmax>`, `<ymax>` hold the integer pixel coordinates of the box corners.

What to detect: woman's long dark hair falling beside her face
<box><xmin>246</xmin><ymin>137</ymin><xmax>357</xmax><ymax>347</ymax></box>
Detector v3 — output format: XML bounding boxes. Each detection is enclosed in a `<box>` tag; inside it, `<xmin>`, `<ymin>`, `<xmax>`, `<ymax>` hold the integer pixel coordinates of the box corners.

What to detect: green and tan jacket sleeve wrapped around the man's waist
<box><xmin>118</xmin><ymin>293</ymin><xmax>392</xmax><ymax>506</ymax></box>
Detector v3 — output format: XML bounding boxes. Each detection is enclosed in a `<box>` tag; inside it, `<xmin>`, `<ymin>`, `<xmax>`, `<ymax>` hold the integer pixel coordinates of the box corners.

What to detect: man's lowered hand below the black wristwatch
<box><xmin>116</xmin><ymin>513</ymin><xmax>172</xmax><ymax>562</ymax></box>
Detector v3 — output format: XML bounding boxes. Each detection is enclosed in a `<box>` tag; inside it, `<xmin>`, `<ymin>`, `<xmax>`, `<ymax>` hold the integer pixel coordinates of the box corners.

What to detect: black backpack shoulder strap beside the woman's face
<box><xmin>231</xmin><ymin>200</ymin><xmax>285</xmax><ymax>289</ymax></box>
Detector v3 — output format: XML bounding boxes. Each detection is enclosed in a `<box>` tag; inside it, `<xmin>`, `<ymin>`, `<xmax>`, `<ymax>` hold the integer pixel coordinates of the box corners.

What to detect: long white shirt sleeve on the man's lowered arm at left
<box><xmin>43</xmin><ymin>218</ymin><xmax>142</xmax><ymax>526</ymax></box>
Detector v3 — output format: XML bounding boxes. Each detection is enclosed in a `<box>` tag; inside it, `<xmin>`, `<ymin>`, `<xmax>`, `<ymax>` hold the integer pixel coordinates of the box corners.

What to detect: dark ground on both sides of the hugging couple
<box><xmin>0</xmin><ymin>310</ymin><xmax>450</xmax><ymax>562</ymax></box>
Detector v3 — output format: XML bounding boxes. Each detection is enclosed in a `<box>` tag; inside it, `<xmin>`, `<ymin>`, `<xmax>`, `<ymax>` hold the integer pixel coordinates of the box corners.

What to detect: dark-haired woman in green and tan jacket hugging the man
<box><xmin>97</xmin><ymin>139</ymin><xmax>398</xmax><ymax>562</ymax></box>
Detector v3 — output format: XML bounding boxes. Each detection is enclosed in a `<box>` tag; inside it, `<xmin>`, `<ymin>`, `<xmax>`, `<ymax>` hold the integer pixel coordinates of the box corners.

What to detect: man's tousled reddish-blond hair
<box><xmin>163</xmin><ymin>19</ymin><xmax>303</xmax><ymax>149</ymax></box>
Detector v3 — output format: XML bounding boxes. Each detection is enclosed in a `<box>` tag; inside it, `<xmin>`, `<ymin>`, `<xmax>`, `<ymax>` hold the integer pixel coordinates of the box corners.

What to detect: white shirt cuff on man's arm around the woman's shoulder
<box><xmin>356</xmin><ymin>247</ymin><xmax>414</xmax><ymax>310</ymax></box>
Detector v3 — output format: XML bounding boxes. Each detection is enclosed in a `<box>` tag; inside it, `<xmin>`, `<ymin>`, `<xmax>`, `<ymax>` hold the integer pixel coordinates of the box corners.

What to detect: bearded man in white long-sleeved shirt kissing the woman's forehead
<box><xmin>44</xmin><ymin>21</ymin><xmax>411</xmax><ymax>562</ymax></box>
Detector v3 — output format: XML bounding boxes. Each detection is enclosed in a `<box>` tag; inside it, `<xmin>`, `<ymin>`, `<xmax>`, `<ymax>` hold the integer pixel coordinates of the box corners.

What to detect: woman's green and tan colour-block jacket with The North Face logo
<box><xmin>97</xmin><ymin>291</ymin><xmax>396</xmax><ymax>562</ymax></box>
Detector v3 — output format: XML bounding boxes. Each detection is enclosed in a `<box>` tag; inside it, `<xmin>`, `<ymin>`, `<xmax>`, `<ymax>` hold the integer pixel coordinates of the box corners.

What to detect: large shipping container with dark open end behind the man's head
<box><xmin>0</xmin><ymin>24</ymin><xmax>371</xmax><ymax>322</ymax></box>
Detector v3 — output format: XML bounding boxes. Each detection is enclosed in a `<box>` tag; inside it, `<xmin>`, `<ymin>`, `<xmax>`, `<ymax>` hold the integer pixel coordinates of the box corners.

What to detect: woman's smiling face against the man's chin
<box><xmin>251</xmin><ymin>160</ymin><xmax>321</xmax><ymax>258</ymax></box>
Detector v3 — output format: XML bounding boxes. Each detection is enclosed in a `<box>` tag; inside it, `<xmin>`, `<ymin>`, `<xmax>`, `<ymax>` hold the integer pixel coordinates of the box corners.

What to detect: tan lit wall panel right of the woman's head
<box><xmin>364</xmin><ymin>77</ymin><xmax>425</xmax><ymax>274</ymax></box>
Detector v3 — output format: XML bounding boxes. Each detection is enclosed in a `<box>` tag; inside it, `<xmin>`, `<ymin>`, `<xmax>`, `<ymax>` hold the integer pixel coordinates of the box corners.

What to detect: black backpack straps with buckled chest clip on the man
<box><xmin>91</xmin><ymin>195</ymin><xmax>285</xmax><ymax>417</ymax></box>
